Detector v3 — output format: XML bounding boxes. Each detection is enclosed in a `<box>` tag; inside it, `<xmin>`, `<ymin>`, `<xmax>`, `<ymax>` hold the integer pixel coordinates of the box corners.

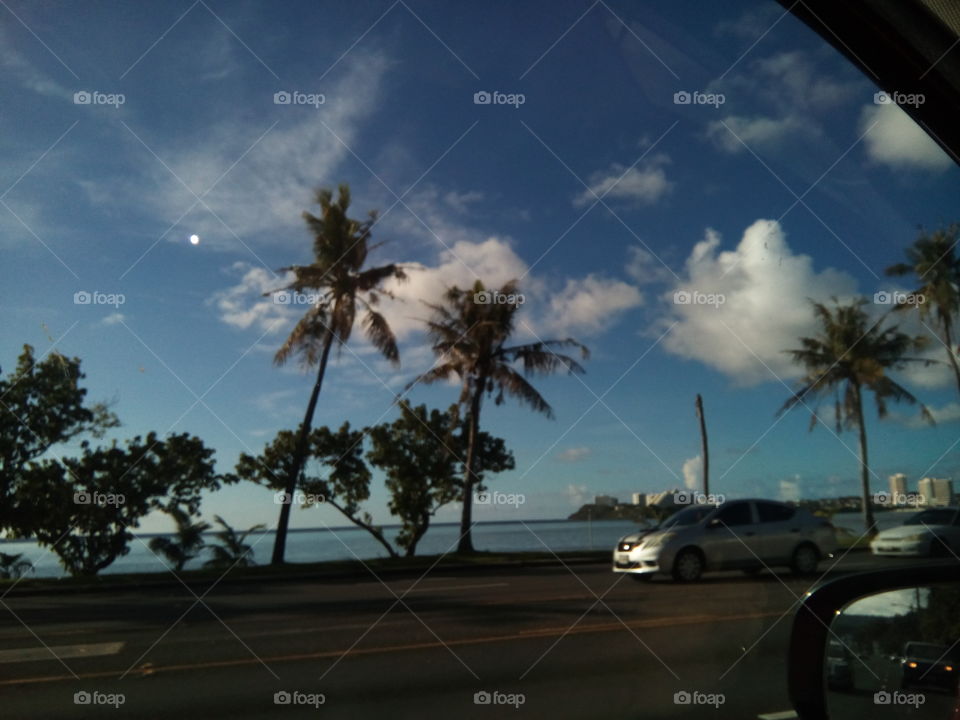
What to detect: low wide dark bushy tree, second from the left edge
<box><xmin>22</xmin><ymin>433</ymin><xmax>221</xmax><ymax>575</ymax></box>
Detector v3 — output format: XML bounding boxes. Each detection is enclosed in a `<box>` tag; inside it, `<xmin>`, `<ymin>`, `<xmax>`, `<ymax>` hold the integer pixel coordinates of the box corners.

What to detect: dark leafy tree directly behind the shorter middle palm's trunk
<box><xmin>367</xmin><ymin>401</ymin><xmax>514</xmax><ymax>556</ymax></box>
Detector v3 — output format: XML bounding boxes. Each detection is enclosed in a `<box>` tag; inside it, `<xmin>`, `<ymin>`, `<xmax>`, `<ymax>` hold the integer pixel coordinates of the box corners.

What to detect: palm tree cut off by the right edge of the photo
<box><xmin>887</xmin><ymin>224</ymin><xmax>960</xmax><ymax>391</ymax></box>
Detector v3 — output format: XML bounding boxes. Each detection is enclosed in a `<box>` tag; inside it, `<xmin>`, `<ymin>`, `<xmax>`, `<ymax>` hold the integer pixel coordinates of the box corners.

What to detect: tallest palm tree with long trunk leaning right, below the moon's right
<box><xmin>267</xmin><ymin>185</ymin><xmax>406</xmax><ymax>565</ymax></box>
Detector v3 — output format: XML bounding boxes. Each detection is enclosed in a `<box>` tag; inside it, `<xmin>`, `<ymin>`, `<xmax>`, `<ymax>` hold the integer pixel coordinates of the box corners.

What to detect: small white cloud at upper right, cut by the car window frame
<box><xmin>860</xmin><ymin>103</ymin><xmax>953</xmax><ymax>170</ymax></box>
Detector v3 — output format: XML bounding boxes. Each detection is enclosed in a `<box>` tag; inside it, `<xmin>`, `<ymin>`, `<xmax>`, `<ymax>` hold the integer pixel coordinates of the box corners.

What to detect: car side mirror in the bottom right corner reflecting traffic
<box><xmin>788</xmin><ymin>560</ymin><xmax>960</xmax><ymax>720</ymax></box>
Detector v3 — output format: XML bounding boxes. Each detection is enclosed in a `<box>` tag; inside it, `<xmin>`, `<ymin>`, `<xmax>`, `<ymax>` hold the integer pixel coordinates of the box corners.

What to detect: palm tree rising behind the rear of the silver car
<box><xmin>777</xmin><ymin>298</ymin><xmax>933</xmax><ymax>532</ymax></box>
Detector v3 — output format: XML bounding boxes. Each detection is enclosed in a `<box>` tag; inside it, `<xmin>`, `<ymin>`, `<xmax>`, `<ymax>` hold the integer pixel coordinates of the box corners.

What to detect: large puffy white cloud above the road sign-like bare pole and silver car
<box><xmin>663</xmin><ymin>220</ymin><xmax>856</xmax><ymax>384</ymax></box>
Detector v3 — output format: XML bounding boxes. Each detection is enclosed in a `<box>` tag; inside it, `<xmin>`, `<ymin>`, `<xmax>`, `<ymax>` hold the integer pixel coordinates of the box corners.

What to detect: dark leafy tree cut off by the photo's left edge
<box><xmin>0</xmin><ymin>345</ymin><xmax>119</xmax><ymax>534</ymax></box>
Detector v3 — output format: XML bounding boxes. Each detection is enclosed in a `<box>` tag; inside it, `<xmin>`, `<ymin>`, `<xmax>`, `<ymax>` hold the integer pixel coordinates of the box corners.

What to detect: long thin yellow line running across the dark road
<box><xmin>0</xmin><ymin>612</ymin><xmax>783</xmax><ymax>687</ymax></box>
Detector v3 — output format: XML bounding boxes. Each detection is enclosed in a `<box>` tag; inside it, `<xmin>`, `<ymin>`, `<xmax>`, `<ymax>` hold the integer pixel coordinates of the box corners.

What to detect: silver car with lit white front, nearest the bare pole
<box><xmin>613</xmin><ymin>500</ymin><xmax>837</xmax><ymax>582</ymax></box>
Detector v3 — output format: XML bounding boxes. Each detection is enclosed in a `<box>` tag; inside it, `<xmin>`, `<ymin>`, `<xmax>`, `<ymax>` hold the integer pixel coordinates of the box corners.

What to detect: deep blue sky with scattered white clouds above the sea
<box><xmin>0</xmin><ymin>0</ymin><xmax>960</xmax><ymax>530</ymax></box>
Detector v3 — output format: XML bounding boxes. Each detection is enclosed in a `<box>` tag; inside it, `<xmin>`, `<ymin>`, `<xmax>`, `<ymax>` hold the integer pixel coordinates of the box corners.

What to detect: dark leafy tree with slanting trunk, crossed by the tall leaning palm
<box><xmin>236</xmin><ymin>422</ymin><xmax>397</xmax><ymax>557</ymax></box>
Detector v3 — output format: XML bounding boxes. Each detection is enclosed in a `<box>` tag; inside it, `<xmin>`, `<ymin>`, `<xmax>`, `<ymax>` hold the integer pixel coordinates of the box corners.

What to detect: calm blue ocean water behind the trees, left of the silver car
<box><xmin>0</xmin><ymin>520</ymin><xmax>637</xmax><ymax>577</ymax></box>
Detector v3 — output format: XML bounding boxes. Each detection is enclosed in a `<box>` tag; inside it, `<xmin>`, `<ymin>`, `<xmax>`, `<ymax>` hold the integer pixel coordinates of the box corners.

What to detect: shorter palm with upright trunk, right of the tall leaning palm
<box><xmin>408</xmin><ymin>280</ymin><xmax>589</xmax><ymax>553</ymax></box>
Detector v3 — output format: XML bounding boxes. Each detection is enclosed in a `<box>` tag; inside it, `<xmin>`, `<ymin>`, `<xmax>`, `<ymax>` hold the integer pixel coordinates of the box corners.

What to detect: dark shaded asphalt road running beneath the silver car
<box><xmin>0</xmin><ymin>553</ymin><xmax>944</xmax><ymax>720</ymax></box>
